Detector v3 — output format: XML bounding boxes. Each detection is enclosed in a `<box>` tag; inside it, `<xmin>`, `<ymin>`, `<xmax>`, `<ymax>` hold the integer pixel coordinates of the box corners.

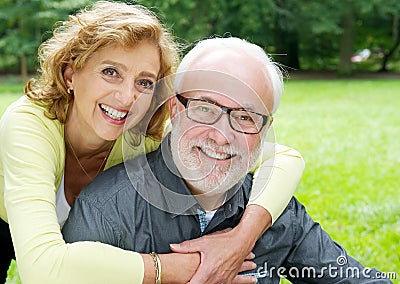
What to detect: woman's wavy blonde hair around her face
<box><xmin>25</xmin><ymin>1</ymin><xmax>179</xmax><ymax>140</ymax></box>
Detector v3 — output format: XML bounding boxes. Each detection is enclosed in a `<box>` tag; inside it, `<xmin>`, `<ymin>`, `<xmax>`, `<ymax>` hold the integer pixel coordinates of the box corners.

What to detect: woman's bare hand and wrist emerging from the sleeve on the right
<box><xmin>171</xmin><ymin>205</ymin><xmax>272</xmax><ymax>284</ymax></box>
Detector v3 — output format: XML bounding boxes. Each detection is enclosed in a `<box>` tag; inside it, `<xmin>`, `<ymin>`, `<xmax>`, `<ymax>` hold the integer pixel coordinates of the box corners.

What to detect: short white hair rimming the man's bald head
<box><xmin>174</xmin><ymin>37</ymin><xmax>283</xmax><ymax>114</ymax></box>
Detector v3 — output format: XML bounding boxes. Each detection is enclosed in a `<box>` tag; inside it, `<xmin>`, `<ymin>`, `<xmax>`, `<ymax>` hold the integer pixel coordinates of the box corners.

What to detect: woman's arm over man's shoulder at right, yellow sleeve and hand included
<box><xmin>172</xmin><ymin>143</ymin><xmax>304</xmax><ymax>283</ymax></box>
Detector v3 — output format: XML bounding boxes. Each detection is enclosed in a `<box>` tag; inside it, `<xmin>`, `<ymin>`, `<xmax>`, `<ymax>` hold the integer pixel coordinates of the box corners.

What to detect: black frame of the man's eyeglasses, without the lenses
<box><xmin>175</xmin><ymin>93</ymin><xmax>274</xmax><ymax>134</ymax></box>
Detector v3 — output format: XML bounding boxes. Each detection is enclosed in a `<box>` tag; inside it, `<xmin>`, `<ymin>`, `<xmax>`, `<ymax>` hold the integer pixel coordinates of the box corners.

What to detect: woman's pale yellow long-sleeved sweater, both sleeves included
<box><xmin>0</xmin><ymin>97</ymin><xmax>304</xmax><ymax>284</ymax></box>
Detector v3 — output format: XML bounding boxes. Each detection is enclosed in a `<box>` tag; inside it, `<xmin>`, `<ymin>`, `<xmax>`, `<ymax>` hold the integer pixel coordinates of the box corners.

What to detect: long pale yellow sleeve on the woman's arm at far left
<box><xmin>0</xmin><ymin>101</ymin><xmax>144</xmax><ymax>284</ymax></box>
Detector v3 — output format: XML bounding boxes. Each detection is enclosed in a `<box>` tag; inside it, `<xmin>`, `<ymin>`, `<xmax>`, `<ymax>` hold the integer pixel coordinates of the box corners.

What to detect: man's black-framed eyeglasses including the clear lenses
<box><xmin>176</xmin><ymin>94</ymin><xmax>273</xmax><ymax>134</ymax></box>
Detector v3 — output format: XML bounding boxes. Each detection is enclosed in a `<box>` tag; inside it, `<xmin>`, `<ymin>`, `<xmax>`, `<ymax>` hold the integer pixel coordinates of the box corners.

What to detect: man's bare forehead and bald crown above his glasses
<box><xmin>175</xmin><ymin>45</ymin><xmax>274</xmax><ymax>112</ymax></box>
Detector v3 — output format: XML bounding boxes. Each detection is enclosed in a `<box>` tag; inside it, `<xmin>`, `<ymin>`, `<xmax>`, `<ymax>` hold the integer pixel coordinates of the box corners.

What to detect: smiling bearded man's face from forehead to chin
<box><xmin>170</xmin><ymin>51</ymin><xmax>272</xmax><ymax>199</ymax></box>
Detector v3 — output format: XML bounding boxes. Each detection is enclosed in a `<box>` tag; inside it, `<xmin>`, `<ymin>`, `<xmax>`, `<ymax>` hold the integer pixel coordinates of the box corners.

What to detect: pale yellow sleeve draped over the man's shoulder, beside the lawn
<box><xmin>249</xmin><ymin>142</ymin><xmax>305</xmax><ymax>223</ymax></box>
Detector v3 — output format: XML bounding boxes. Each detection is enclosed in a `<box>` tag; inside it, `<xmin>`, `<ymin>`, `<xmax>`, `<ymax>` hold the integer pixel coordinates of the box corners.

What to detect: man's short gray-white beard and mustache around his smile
<box><xmin>171</xmin><ymin>127</ymin><xmax>261</xmax><ymax>195</ymax></box>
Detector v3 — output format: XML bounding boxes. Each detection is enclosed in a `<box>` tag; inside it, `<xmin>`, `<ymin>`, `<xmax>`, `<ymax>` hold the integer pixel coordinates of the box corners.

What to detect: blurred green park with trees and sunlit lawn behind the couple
<box><xmin>0</xmin><ymin>0</ymin><xmax>400</xmax><ymax>283</ymax></box>
